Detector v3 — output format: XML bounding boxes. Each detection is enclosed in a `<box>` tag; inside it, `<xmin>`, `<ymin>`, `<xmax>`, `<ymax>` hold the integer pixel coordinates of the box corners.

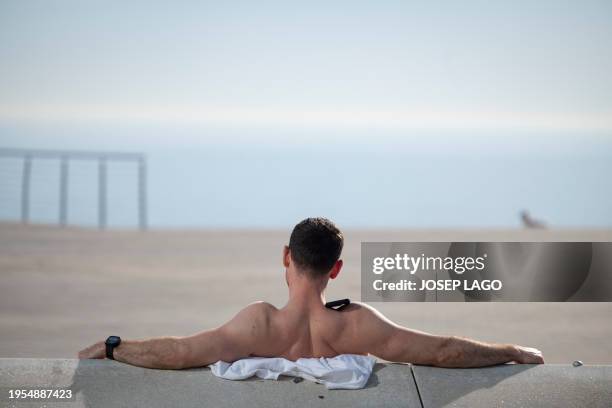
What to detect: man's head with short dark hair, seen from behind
<box><xmin>285</xmin><ymin>217</ymin><xmax>344</xmax><ymax>279</ymax></box>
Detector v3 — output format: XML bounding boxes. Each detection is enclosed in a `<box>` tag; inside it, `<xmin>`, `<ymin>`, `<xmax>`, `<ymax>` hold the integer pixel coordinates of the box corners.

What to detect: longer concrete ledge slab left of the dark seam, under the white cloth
<box><xmin>0</xmin><ymin>359</ymin><xmax>421</xmax><ymax>408</ymax></box>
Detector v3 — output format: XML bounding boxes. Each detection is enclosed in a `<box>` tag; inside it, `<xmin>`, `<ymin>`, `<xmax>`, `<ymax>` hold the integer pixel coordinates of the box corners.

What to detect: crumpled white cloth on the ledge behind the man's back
<box><xmin>210</xmin><ymin>354</ymin><xmax>376</xmax><ymax>390</ymax></box>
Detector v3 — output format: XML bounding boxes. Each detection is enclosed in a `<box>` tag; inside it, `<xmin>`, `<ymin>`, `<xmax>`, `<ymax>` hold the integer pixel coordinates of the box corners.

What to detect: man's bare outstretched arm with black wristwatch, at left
<box><xmin>79</xmin><ymin>303</ymin><xmax>270</xmax><ymax>369</ymax></box>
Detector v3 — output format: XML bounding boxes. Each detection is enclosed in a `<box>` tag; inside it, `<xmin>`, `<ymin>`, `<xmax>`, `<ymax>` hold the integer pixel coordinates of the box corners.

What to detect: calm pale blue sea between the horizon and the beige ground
<box><xmin>0</xmin><ymin>124</ymin><xmax>612</xmax><ymax>228</ymax></box>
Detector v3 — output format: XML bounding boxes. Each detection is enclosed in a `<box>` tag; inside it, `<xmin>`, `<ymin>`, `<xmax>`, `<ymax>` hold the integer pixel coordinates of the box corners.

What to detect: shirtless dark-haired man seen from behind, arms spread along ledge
<box><xmin>79</xmin><ymin>218</ymin><xmax>544</xmax><ymax>369</ymax></box>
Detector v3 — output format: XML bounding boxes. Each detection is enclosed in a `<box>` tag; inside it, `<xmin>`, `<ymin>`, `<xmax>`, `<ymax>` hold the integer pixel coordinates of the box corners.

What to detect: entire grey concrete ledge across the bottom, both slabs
<box><xmin>0</xmin><ymin>358</ymin><xmax>612</xmax><ymax>408</ymax></box>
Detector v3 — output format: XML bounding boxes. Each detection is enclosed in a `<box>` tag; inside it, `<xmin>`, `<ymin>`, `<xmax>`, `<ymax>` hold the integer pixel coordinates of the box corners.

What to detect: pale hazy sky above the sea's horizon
<box><xmin>0</xmin><ymin>0</ymin><xmax>612</xmax><ymax>131</ymax></box>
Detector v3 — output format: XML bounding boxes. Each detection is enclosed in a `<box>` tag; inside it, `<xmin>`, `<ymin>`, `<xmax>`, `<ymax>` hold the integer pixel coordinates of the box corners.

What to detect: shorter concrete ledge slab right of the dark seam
<box><xmin>412</xmin><ymin>364</ymin><xmax>612</xmax><ymax>408</ymax></box>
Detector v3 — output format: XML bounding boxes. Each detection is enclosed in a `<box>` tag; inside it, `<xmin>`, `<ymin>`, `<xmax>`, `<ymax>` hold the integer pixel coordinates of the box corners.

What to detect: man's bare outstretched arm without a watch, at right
<box><xmin>346</xmin><ymin>305</ymin><xmax>544</xmax><ymax>367</ymax></box>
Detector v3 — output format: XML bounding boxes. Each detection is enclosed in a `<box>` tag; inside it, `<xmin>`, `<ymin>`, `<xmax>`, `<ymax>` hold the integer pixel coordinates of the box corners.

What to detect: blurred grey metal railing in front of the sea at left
<box><xmin>0</xmin><ymin>148</ymin><xmax>147</xmax><ymax>230</ymax></box>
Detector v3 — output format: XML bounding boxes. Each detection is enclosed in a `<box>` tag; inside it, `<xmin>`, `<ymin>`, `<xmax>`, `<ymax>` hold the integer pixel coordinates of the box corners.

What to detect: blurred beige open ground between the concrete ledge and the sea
<box><xmin>0</xmin><ymin>223</ymin><xmax>612</xmax><ymax>363</ymax></box>
